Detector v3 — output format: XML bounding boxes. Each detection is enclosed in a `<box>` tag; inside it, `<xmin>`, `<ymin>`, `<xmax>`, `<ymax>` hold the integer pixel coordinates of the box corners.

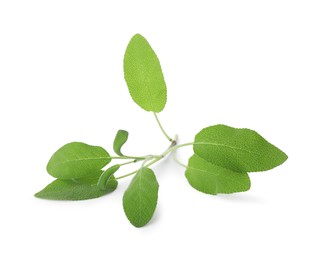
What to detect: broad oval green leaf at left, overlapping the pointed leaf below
<box><xmin>47</xmin><ymin>142</ymin><xmax>111</xmax><ymax>179</ymax></box>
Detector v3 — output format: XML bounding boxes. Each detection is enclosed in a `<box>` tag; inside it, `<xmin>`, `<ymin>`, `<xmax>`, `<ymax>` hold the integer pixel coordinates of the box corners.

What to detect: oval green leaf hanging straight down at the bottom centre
<box><xmin>123</xmin><ymin>167</ymin><xmax>159</xmax><ymax>227</ymax></box>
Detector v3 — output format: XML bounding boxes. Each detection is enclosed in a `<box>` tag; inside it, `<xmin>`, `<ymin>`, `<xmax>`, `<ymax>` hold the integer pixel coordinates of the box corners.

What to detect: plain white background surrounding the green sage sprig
<box><xmin>0</xmin><ymin>0</ymin><xmax>324</xmax><ymax>260</ymax></box>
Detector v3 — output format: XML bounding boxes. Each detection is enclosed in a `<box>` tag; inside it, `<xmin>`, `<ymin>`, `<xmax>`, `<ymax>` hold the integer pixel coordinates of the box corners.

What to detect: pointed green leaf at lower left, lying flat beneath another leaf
<box><xmin>35</xmin><ymin>171</ymin><xmax>118</xmax><ymax>200</ymax></box>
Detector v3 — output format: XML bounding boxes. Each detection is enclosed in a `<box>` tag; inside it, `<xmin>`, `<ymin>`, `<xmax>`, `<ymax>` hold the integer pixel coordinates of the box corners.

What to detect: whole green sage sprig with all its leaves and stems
<box><xmin>35</xmin><ymin>34</ymin><xmax>288</xmax><ymax>227</ymax></box>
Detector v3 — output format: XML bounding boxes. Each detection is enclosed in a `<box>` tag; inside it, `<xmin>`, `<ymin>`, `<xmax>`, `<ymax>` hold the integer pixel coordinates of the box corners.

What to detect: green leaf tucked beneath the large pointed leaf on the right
<box><xmin>186</xmin><ymin>155</ymin><xmax>251</xmax><ymax>195</ymax></box>
